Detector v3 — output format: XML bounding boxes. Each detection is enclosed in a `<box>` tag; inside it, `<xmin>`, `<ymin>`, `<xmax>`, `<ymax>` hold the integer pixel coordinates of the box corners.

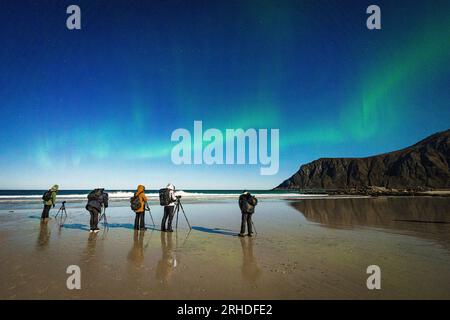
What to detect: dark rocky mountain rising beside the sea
<box><xmin>275</xmin><ymin>129</ymin><xmax>450</xmax><ymax>190</ymax></box>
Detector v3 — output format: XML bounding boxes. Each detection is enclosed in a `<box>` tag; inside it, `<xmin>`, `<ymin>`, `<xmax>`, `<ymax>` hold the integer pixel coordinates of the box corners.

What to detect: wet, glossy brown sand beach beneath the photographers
<box><xmin>0</xmin><ymin>197</ymin><xmax>450</xmax><ymax>299</ymax></box>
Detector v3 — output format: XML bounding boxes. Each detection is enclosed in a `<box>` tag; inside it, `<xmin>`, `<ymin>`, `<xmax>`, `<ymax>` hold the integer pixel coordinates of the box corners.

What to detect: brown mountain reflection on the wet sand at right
<box><xmin>292</xmin><ymin>197</ymin><xmax>450</xmax><ymax>249</ymax></box>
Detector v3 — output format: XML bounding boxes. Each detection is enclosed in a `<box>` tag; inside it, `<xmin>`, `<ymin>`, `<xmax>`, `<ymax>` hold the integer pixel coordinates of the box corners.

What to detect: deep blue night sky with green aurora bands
<box><xmin>0</xmin><ymin>0</ymin><xmax>450</xmax><ymax>189</ymax></box>
